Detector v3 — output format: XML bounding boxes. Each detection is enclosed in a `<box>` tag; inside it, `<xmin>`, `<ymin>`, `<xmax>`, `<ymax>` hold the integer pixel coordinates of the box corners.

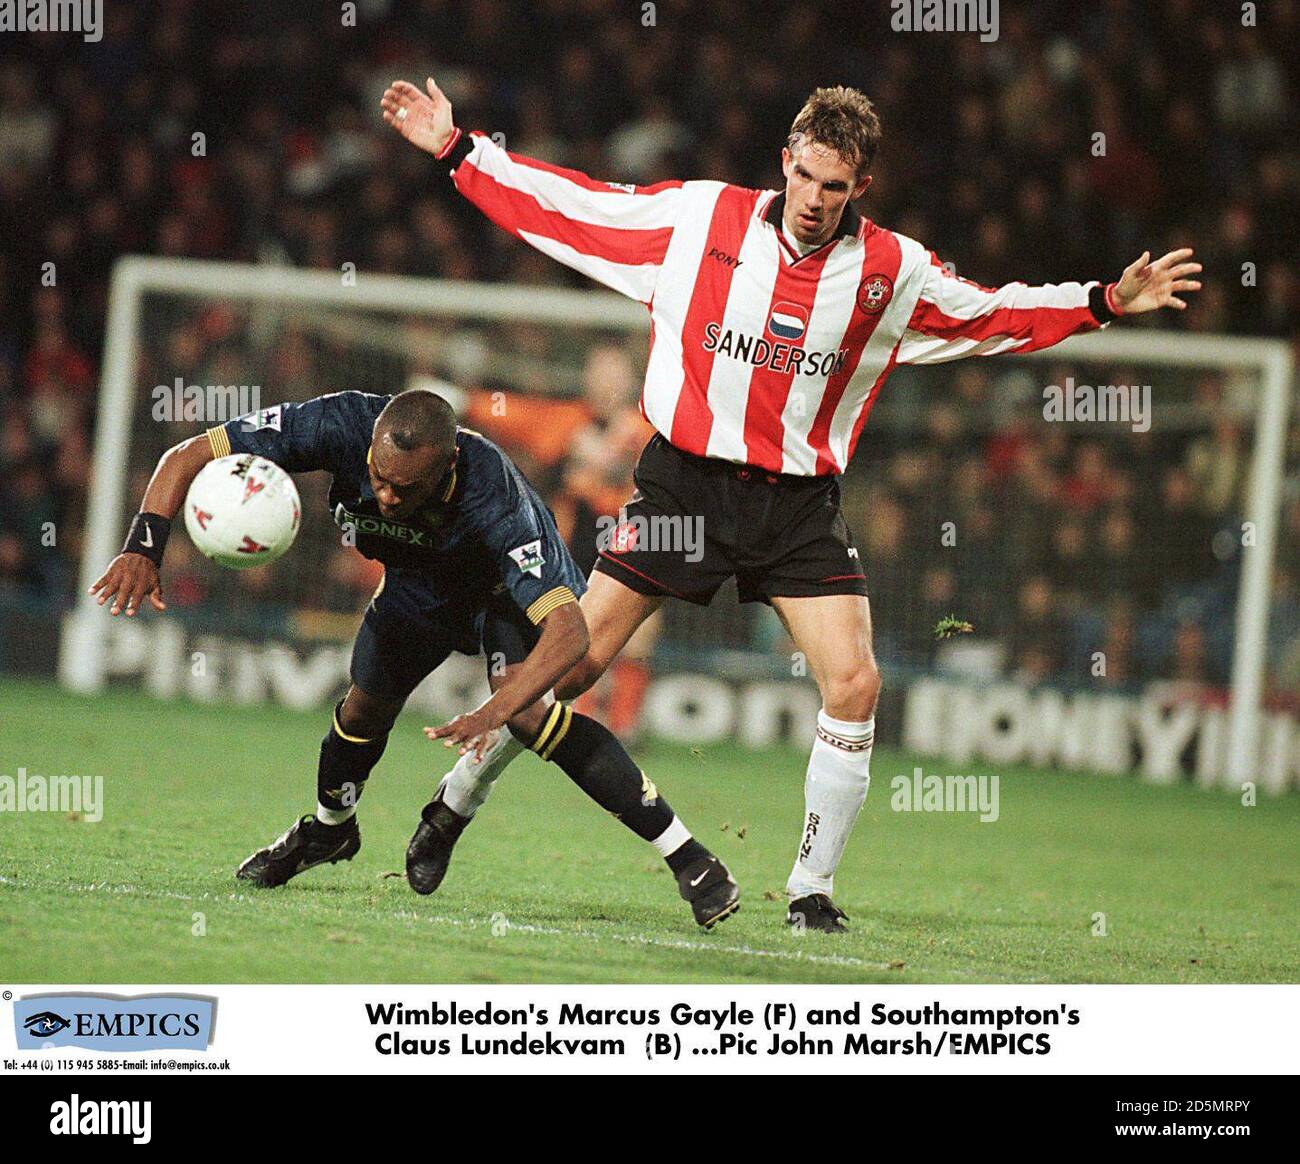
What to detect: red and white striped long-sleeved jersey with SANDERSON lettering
<box><xmin>445</xmin><ymin>134</ymin><xmax>1112</xmax><ymax>476</ymax></box>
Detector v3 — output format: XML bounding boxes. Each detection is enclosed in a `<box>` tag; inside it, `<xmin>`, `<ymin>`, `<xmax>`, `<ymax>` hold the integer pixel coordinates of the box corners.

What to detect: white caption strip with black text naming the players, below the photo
<box><xmin>0</xmin><ymin>985</ymin><xmax>1300</xmax><ymax>1076</ymax></box>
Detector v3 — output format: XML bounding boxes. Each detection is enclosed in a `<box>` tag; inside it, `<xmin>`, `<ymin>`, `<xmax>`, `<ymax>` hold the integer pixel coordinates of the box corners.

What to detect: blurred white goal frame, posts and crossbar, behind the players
<box><xmin>60</xmin><ymin>256</ymin><xmax>1295</xmax><ymax>782</ymax></box>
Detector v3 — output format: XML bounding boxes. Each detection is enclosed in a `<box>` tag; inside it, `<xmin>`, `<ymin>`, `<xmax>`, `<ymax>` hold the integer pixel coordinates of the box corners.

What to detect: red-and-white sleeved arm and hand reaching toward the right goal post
<box><xmin>897</xmin><ymin>247</ymin><xmax>1201</xmax><ymax>364</ymax></box>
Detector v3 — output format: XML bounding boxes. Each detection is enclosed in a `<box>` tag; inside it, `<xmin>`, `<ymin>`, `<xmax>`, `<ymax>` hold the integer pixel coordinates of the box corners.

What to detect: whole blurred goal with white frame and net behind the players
<box><xmin>60</xmin><ymin>259</ymin><xmax>1300</xmax><ymax>791</ymax></box>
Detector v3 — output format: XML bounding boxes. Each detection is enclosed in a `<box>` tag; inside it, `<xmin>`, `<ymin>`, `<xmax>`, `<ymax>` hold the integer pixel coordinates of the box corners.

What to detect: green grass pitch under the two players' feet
<box><xmin>0</xmin><ymin>681</ymin><xmax>1300</xmax><ymax>983</ymax></box>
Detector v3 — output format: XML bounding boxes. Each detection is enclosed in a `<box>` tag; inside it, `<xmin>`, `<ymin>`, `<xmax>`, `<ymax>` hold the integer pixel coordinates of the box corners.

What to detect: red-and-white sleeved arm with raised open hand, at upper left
<box><xmin>380</xmin><ymin>77</ymin><xmax>683</xmax><ymax>303</ymax></box>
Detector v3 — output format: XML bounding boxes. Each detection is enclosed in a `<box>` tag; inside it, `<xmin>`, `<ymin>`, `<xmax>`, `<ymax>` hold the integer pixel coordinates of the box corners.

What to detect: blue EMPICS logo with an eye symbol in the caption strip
<box><xmin>13</xmin><ymin>994</ymin><xmax>217</xmax><ymax>1051</ymax></box>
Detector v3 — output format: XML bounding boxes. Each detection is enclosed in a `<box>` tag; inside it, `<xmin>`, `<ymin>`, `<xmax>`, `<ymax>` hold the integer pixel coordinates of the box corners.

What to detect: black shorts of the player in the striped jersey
<box><xmin>595</xmin><ymin>433</ymin><xmax>867</xmax><ymax>606</ymax></box>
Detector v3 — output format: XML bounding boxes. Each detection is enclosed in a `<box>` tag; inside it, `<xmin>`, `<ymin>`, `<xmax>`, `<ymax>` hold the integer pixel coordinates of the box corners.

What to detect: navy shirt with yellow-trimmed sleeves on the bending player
<box><xmin>208</xmin><ymin>391</ymin><xmax>586</xmax><ymax>624</ymax></box>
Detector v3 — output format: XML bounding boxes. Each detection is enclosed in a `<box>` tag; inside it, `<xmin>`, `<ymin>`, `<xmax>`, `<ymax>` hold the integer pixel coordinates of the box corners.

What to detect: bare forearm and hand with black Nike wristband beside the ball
<box><xmin>90</xmin><ymin>436</ymin><xmax>212</xmax><ymax>618</ymax></box>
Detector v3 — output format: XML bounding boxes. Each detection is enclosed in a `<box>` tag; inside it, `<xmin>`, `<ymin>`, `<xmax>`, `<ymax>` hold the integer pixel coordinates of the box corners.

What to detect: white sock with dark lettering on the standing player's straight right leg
<box><xmin>785</xmin><ymin>710</ymin><xmax>876</xmax><ymax>901</ymax></box>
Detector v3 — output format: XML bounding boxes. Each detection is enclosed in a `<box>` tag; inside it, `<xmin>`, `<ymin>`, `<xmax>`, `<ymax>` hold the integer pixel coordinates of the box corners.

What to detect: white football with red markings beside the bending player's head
<box><xmin>185</xmin><ymin>453</ymin><xmax>302</xmax><ymax>570</ymax></box>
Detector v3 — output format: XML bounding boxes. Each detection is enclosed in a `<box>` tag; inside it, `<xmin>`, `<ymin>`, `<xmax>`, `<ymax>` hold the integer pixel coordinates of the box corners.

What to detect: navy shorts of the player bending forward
<box><xmin>350</xmin><ymin>570</ymin><xmax>541</xmax><ymax>704</ymax></box>
